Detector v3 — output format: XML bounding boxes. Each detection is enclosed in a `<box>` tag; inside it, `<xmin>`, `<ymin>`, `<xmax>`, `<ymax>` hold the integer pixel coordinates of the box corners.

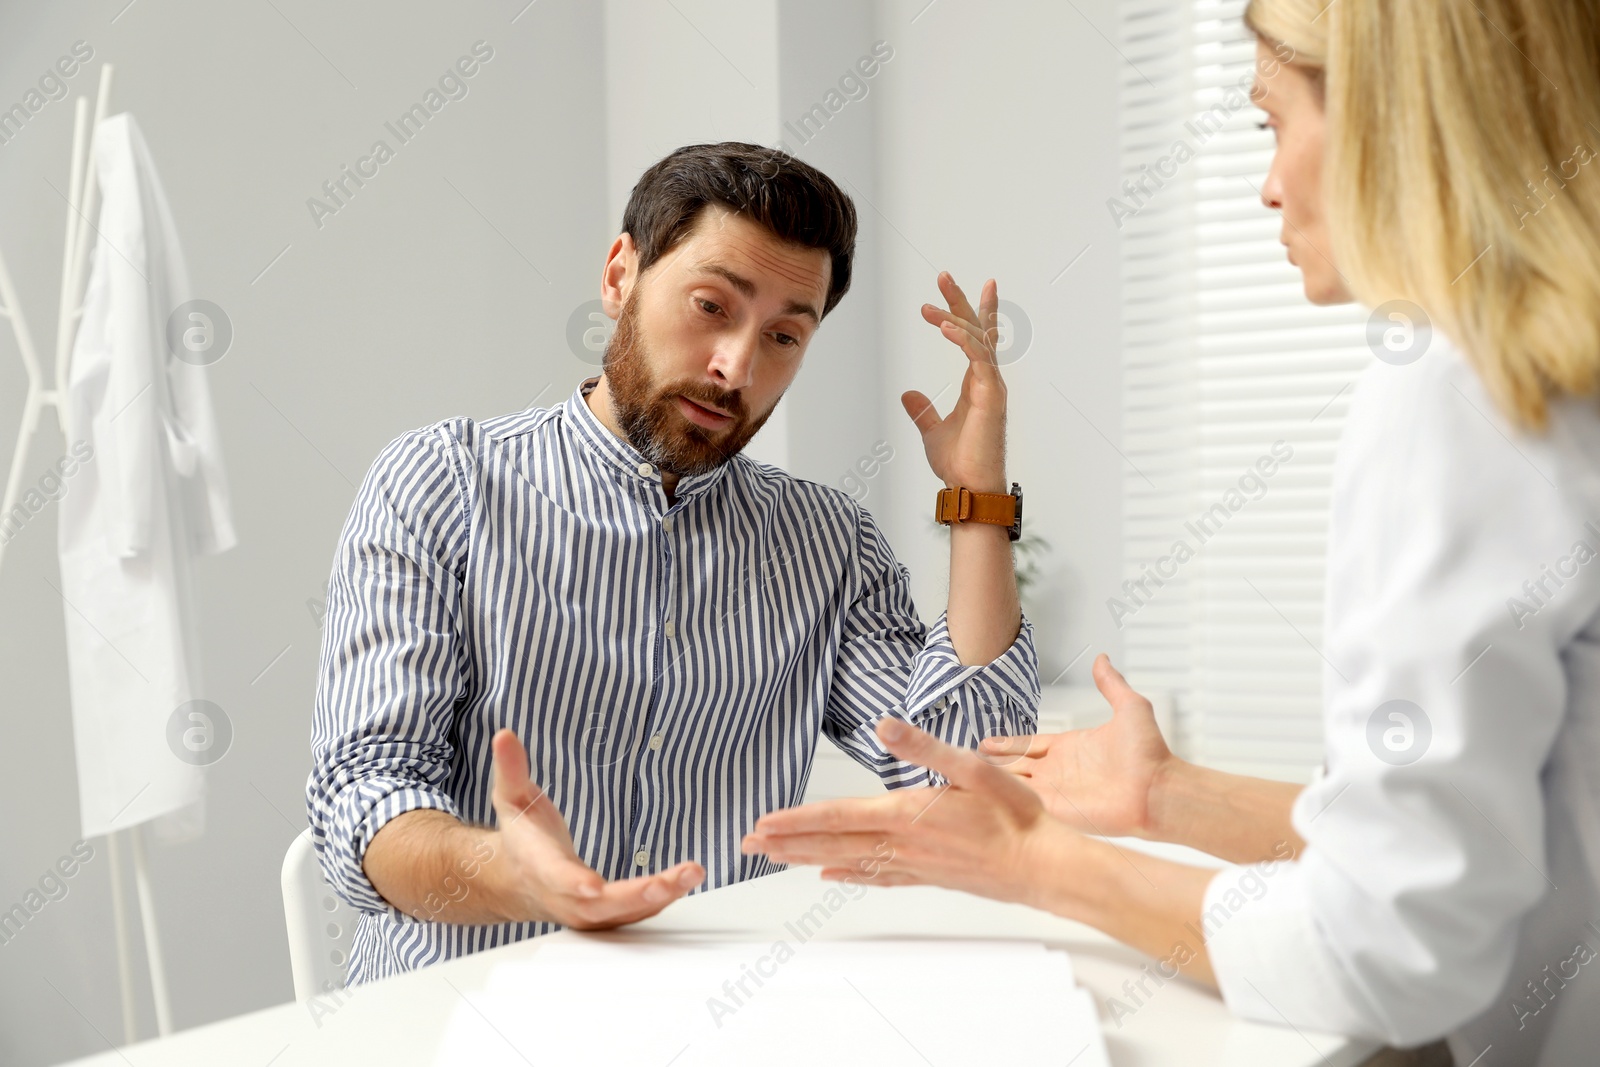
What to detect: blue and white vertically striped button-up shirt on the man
<box><xmin>307</xmin><ymin>379</ymin><xmax>1040</xmax><ymax>985</ymax></box>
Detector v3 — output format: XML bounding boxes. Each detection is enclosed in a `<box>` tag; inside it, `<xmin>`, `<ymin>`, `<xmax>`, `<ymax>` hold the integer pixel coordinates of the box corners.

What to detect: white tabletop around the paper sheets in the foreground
<box><xmin>59</xmin><ymin>867</ymin><xmax>1374</xmax><ymax>1067</ymax></box>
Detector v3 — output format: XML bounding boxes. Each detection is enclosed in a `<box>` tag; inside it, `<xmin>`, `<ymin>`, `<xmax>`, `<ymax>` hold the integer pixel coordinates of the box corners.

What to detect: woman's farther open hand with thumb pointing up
<box><xmin>981</xmin><ymin>654</ymin><xmax>1179</xmax><ymax>837</ymax></box>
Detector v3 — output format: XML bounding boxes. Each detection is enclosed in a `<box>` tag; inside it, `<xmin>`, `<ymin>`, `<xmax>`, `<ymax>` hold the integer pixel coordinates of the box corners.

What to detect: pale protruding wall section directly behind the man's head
<box><xmin>594</xmin><ymin>0</ymin><xmax>883</xmax><ymax>485</ymax></box>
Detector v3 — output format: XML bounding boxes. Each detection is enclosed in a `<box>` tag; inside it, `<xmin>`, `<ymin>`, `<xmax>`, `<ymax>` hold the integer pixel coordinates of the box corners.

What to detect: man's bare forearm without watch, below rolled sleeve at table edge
<box><xmin>362</xmin><ymin>809</ymin><xmax>531</xmax><ymax>923</ymax></box>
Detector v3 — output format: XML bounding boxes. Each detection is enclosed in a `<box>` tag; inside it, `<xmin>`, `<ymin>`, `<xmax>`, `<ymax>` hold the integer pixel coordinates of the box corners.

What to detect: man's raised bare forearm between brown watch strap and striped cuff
<box><xmin>946</xmin><ymin>518</ymin><xmax>1022</xmax><ymax>665</ymax></box>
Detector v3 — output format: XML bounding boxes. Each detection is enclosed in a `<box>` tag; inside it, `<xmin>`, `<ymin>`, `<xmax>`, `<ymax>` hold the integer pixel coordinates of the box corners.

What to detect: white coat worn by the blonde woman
<box><xmin>1205</xmin><ymin>331</ymin><xmax>1600</xmax><ymax>1067</ymax></box>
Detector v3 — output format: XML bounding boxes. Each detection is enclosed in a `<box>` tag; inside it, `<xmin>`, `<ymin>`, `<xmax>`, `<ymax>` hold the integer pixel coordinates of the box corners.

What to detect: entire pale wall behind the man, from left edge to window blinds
<box><xmin>0</xmin><ymin>0</ymin><xmax>1128</xmax><ymax>1065</ymax></box>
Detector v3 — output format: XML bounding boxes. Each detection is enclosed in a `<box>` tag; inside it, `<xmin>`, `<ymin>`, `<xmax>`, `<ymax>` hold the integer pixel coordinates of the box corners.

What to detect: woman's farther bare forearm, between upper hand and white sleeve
<box><xmin>1141</xmin><ymin>758</ymin><xmax>1306</xmax><ymax>864</ymax></box>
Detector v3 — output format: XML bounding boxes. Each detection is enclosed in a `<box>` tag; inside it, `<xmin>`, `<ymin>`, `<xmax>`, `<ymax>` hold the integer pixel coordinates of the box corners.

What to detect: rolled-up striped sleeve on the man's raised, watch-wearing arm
<box><xmin>824</xmin><ymin>495</ymin><xmax>1040</xmax><ymax>789</ymax></box>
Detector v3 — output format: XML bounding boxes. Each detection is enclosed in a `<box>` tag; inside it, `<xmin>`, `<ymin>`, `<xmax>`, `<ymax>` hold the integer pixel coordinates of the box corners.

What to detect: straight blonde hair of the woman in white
<box><xmin>1246</xmin><ymin>0</ymin><xmax>1600</xmax><ymax>429</ymax></box>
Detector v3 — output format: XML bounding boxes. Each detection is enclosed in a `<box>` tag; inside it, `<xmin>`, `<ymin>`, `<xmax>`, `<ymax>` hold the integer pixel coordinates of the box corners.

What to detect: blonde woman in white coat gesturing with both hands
<box><xmin>747</xmin><ymin>0</ymin><xmax>1600</xmax><ymax>1067</ymax></box>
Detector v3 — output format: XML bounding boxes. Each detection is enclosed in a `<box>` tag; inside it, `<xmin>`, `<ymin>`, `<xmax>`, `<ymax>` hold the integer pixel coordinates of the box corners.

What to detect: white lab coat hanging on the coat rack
<box><xmin>58</xmin><ymin>114</ymin><xmax>235</xmax><ymax>838</ymax></box>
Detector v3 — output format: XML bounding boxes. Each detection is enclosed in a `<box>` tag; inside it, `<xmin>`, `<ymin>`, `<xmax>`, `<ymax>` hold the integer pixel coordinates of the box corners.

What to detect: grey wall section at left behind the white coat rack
<box><xmin>0</xmin><ymin>0</ymin><xmax>614</xmax><ymax>1067</ymax></box>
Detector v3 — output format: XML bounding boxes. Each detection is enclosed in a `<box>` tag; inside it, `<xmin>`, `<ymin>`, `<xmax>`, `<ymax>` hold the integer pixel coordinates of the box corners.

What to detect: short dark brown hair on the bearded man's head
<box><xmin>622</xmin><ymin>141</ymin><xmax>856</xmax><ymax>317</ymax></box>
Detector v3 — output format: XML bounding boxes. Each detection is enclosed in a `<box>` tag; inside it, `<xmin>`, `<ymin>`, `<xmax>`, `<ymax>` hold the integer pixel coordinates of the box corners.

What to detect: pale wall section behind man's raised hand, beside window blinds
<box><xmin>869</xmin><ymin>0</ymin><xmax>1128</xmax><ymax>683</ymax></box>
